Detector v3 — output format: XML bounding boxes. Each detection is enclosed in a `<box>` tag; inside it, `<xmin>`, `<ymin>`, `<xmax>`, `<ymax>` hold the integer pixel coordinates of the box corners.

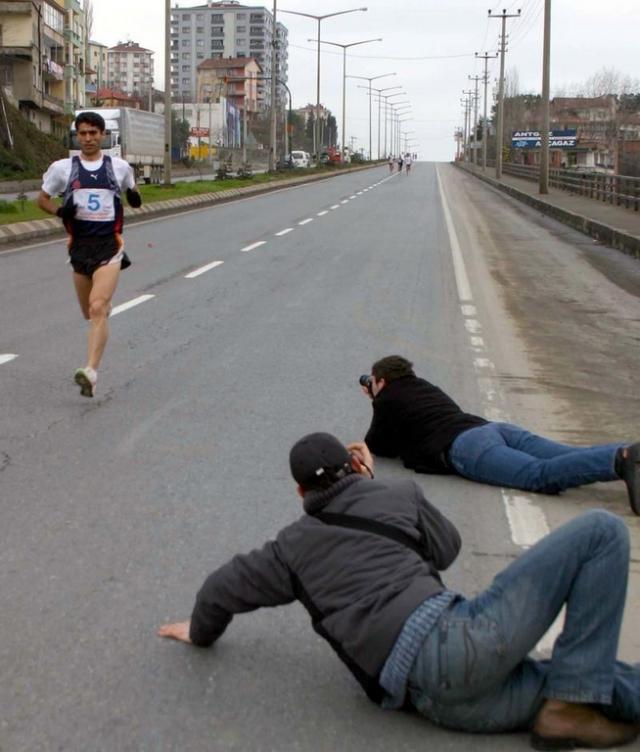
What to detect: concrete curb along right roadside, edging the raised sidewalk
<box><xmin>454</xmin><ymin>164</ymin><xmax>640</xmax><ymax>259</ymax></box>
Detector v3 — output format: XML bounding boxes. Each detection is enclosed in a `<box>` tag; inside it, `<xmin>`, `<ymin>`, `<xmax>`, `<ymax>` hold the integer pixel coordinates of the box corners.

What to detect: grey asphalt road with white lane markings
<box><xmin>0</xmin><ymin>164</ymin><xmax>640</xmax><ymax>752</ymax></box>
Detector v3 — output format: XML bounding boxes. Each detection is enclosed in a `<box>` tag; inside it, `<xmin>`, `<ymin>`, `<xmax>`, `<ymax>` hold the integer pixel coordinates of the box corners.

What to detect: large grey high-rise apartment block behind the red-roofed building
<box><xmin>171</xmin><ymin>0</ymin><xmax>288</xmax><ymax>109</ymax></box>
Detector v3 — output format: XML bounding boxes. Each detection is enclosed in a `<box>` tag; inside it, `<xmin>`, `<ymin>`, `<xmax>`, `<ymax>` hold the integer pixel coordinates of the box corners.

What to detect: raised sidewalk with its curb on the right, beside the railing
<box><xmin>456</xmin><ymin>163</ymin><xmax>640</xmax><ymax>258</ymax></box>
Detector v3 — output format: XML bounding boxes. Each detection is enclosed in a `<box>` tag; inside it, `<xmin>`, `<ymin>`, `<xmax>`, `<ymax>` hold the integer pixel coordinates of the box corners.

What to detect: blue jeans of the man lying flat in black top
<box><xmin>449</xmin><ymin>423</ymin><xmax>623</xmax><ymax>493</ymax></box>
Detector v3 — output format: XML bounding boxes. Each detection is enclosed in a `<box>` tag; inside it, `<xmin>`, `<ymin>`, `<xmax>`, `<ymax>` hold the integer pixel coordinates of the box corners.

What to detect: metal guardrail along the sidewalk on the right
<box><xmin>480</xmin><ymin>162</ymin><xmax>640</xmax><ymax>211</ymax></box>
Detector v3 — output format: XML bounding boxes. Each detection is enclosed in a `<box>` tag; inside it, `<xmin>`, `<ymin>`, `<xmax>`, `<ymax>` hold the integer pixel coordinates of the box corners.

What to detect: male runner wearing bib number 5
<box><xmin>38</xmin><ymin>112</ymin><xmax>142</xmax><ymax>397</ymax></box>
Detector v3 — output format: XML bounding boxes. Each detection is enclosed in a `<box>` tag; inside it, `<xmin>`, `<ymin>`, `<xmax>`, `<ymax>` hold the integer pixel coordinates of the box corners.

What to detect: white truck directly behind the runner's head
<box><xmin>69</xmin><ymin>107</ymin><xmax>164</xmax><ymax>183</ymax></box>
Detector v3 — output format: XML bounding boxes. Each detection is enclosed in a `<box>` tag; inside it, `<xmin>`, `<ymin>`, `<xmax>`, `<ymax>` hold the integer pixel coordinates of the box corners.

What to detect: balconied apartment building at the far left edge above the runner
<box><xmin>0</xmin><ymin>0</ymin><xmax>85</xmax><ymax>134</ymax></box>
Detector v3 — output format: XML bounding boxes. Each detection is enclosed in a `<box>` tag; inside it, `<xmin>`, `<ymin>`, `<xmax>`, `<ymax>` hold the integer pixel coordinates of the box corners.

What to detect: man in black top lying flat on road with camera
<box><xmin>360</xmin><ymin>355</ymin><xmax>640</xmax><ymax>514</ymax></box>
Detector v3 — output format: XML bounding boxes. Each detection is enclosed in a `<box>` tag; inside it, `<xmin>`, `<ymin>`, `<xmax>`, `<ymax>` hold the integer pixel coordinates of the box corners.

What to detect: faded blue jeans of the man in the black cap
<box><xmin>408</xmin><ymin>510</ymin><xmax>640</xmax><ymax>732</ymax></box>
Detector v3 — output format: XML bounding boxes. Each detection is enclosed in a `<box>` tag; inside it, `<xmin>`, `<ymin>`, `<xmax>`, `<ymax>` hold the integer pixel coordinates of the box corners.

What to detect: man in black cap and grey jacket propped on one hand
<box><xmin>158</xmin><ymin>433</ymin><xmax>640</xmax><ymax>749</ymax></box>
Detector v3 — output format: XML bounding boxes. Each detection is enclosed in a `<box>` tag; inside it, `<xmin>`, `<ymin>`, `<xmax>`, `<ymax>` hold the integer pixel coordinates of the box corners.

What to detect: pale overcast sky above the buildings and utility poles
<box><xmin>93</xmin><ymin>0</ymin><xmax>640</xmax><ymax>160</ymax></box>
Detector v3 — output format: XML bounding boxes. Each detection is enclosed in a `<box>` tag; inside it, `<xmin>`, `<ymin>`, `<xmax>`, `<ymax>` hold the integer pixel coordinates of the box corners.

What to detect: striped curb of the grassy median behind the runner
<box><xmin>0</xmin><ymin>163</ymin><xmax>382</xmax><ymax>250</ymax></box>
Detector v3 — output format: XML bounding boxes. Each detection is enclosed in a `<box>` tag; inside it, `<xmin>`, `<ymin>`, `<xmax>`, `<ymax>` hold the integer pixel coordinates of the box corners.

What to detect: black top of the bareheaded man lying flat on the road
<box><xmin>364</xmin><ymin>376</ymin><xmax>488</xmax><ymax>473</ymax></box>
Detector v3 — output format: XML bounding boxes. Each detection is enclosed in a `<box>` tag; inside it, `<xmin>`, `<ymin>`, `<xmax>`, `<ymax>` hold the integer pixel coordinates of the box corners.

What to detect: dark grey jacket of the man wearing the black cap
<box><xmin>190</xmin><ymin>475</ymin><xmax>460</xmax><ymax>701</ymax></box>
